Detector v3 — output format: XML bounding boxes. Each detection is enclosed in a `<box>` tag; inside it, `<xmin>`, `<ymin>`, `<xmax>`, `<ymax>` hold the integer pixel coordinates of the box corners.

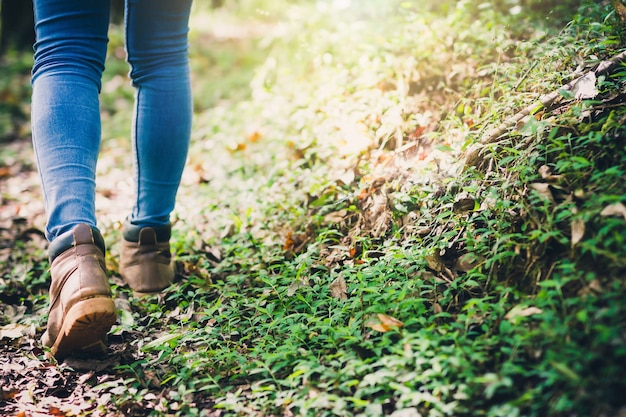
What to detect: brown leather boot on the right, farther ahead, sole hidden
<box><xmin>120</xmin><ymin>223</ymin><xmax>175</xmax><ymax>295</ymax></box>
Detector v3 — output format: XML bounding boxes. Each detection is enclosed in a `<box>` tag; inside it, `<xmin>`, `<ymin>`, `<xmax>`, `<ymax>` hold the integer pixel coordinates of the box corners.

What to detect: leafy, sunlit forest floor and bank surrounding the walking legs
<box><xmin>0</xmin><ymin>0</ymin><xmax>626</xmax><ymax>417</ymax></box>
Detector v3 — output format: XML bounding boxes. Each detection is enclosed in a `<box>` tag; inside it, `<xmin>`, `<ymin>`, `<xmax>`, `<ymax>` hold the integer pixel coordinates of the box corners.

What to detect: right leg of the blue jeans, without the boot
<box><xmin>126</xmin><ymin>0</ymin><xmax>192</xmax><ymax>226</ymax></box>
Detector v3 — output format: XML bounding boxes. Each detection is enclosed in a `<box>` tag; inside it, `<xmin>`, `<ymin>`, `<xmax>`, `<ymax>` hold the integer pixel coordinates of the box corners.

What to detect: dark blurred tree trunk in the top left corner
<box><xmin>0</xmin><ymin>0</ymin><xmax>35</xmax><ymax>53</ymax></box>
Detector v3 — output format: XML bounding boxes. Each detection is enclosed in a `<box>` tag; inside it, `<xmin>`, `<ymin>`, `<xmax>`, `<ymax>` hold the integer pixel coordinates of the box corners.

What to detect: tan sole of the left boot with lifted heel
<box><xmin>50</xmin><ymin>297</ymin><xmax>117</xmax><ymax>360</ymax></box>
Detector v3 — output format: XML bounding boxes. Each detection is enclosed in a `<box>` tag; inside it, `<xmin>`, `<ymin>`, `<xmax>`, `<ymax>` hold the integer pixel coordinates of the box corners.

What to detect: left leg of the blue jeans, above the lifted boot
<box><xmin>31</xmin><ymin>0</ymin><xmax>109</xmax><ymax>241</ymax></box>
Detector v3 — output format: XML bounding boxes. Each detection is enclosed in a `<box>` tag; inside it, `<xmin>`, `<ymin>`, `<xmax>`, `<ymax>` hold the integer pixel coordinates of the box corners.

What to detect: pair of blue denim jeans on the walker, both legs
<box><xmin>31</xmin><ymin>0</ymin><xmax>192</xmax><ymax>241</ymax></box>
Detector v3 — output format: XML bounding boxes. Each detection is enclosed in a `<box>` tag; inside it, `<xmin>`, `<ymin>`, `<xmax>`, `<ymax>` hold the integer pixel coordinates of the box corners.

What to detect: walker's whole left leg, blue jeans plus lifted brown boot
<box><xmin>31</xmin><ymin>0</ymin><xmax>116</xmax><ymax>360</ymax></box>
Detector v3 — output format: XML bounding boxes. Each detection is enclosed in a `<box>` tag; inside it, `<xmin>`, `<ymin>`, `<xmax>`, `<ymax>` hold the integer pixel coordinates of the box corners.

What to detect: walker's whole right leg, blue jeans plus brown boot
<box><xmin>120</xmin><ymin>0</ymin><xmax>192</xmax><ymax>294</ymax></box>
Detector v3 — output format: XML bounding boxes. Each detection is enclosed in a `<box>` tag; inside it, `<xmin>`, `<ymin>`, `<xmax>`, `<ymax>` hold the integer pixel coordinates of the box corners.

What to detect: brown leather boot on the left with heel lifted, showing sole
<box><xmin>42</xmin><ymin>224</ymin><xmax>117</xmax><ymax>360</ymax></box>
